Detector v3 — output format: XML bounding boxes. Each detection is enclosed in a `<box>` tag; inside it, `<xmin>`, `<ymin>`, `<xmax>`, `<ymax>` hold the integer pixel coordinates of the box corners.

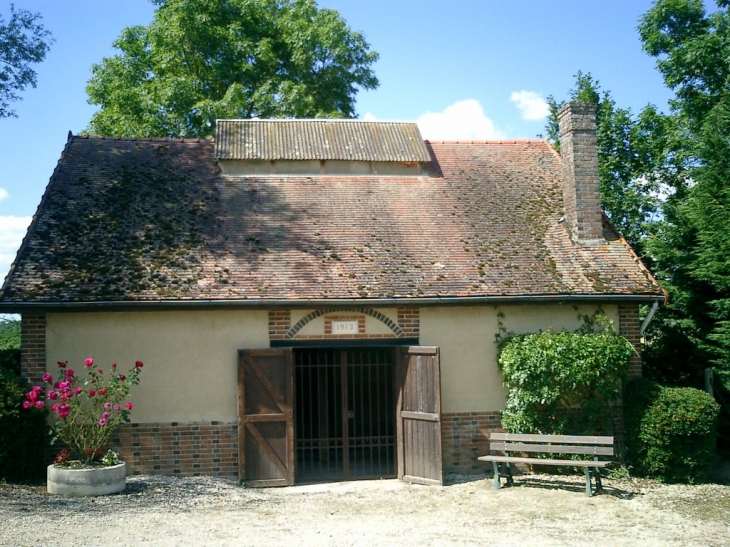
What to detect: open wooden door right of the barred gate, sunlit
<box><xmin>396</xmin><ymin>346</ymin><xmax>443</xmax><ymax>485</ymax></box>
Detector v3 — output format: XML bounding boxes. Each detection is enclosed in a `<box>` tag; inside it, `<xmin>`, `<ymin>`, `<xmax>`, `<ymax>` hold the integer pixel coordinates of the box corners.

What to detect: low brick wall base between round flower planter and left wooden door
<box><xmin>110</xmin><ymin>422</ymin><xmax>238</xmax><ymax>477</ymax></box>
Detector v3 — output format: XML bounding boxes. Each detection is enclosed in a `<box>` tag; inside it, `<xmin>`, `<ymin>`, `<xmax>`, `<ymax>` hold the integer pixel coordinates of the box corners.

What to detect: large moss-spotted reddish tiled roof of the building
<box><xmin>0</xmin><ymin>137</ymin><xmax>660</xmax><ymax>309</ymax></box>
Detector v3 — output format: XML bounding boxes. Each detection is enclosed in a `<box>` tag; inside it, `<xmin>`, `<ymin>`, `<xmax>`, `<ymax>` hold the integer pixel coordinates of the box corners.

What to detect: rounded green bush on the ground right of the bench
<box><xmin>624</xmin><ymin>379</ymin><xmax>720</xmax><ymax>483</ymax></box>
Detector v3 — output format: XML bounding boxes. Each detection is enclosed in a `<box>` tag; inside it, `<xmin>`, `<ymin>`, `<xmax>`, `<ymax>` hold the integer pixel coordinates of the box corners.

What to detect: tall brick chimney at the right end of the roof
<box><xmin>558</xmin><ymin>103</ymin><xmax>603</xmax><ymax>242</ymax></box>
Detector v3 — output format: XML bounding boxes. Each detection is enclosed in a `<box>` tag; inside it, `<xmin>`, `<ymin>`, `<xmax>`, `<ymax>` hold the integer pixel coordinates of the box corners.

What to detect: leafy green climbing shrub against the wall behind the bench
<box><xmin>499</xmin><ymin>329</ymin><xmax>634</xmax><ymax>435</ymax></box>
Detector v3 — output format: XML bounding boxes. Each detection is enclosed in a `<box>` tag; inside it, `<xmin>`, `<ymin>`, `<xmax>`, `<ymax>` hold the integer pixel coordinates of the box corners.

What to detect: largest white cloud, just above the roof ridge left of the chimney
<box><xmin>416</xmin><ymin>99</ymin><xmax>501</xmax><ymax>141</ymax></box>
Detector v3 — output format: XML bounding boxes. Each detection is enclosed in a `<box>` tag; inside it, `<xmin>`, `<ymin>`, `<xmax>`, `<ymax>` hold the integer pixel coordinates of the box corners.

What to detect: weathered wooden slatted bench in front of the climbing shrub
<box><xmin>477</xmin><ymin>433</ymin><xmax>613</xmax><ymax>496</ymax></box>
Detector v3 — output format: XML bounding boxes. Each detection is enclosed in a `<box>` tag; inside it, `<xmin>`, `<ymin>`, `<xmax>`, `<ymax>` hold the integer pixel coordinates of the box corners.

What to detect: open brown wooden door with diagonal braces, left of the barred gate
<box><xmin>238</xmin><ymin>348</ymin><xmax>295</xmax><ymax>486</ymax></box>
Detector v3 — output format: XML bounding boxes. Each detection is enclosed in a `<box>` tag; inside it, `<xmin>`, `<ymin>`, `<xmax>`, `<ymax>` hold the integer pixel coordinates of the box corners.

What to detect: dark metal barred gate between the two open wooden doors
<box><xmin>294</xmin><ymin>348</ymin><xmax>396</xmax><ymax>482</ymax></box>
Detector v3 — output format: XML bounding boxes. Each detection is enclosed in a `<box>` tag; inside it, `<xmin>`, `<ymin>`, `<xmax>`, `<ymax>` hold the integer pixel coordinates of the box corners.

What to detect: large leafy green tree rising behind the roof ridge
<box><xmin>87</xmin><ymin>0</ymin><xmax>378</xmax><ymax>137</ymax></box>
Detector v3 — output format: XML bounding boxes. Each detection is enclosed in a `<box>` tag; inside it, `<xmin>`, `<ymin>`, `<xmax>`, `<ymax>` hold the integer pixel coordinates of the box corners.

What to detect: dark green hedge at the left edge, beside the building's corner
<box><xmin>0</xmin><ymin>350</ymin><xmax>46</xmax><ymax>481</ymax></box>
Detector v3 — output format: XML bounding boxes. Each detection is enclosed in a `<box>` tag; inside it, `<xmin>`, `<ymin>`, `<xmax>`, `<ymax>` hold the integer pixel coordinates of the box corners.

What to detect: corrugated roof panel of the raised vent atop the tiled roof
<box><xmin>215</xmin><ymin>120</ymin><xmax>431</xmax><ymax>162</ymax></box>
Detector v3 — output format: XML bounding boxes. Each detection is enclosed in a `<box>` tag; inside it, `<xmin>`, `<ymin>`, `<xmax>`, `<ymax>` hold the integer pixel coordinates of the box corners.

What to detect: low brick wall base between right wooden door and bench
<box><xmin>441</xmin><ymin>411</ymin><xmax>502</xmax><ymax>474</ymax></box>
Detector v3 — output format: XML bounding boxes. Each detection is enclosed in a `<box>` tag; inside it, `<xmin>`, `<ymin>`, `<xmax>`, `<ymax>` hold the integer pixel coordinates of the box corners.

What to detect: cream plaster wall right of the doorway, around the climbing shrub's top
<box><xmin>420</xmin><ymin>305</ymin><xmax>618</xmax><ymax>412</ymax></box>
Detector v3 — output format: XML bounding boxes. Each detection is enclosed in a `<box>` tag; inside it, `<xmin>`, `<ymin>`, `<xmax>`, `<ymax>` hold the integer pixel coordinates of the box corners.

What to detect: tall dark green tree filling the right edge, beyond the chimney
<box><xmin>639</xmin><ymin>0</ymin><xmax>730</xmax><ymax>387</ymax></box>
